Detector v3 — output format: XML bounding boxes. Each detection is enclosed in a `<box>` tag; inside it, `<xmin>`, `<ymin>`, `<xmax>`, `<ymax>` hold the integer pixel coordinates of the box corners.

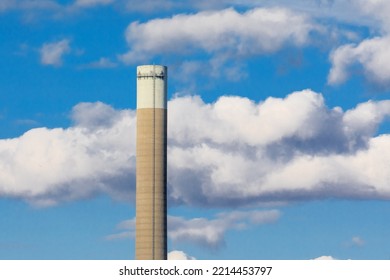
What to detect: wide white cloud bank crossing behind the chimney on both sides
<box><xmin>0</xmin><ymin>90</ymin><xmax>390</xmax><ymax>207</ymax></box>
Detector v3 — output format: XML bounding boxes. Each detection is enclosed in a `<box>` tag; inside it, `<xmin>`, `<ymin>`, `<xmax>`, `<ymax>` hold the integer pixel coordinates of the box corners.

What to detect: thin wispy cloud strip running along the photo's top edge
<box><xmin>0</xmin><ymin>0</ymin><xmax>390</xmax><ymax>37</ymax></box>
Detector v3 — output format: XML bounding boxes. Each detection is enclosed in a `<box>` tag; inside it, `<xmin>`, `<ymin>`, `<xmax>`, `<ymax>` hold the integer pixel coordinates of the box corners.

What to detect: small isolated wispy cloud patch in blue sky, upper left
<box><xmin>40</xmin><ymin>39</ymin><xmax>71</xmax><ymax>66</ymax></box>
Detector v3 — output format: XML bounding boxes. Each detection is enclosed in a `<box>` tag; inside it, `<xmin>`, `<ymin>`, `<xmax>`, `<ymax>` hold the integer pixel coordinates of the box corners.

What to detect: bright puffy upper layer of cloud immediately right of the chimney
<box><xmin>169</xmin><ymin>90</ymin><xmax>341</xmax><ymax>145</ymax></box>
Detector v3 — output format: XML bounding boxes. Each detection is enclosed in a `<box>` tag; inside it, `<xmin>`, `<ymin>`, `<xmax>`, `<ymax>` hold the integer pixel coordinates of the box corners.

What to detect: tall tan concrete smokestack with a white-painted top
<box><xmin>135</xmin><ymin>65</ymin><xmax>167</xmax><ymax>260</ymax></box>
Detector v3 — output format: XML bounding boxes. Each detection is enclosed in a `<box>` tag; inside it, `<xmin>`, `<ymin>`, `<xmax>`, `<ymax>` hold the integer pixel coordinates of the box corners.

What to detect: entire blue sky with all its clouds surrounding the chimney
<box><xmin>0</xmin><ymin>0</ymin><xmax>390</xmax><ymax>259</ymax></box>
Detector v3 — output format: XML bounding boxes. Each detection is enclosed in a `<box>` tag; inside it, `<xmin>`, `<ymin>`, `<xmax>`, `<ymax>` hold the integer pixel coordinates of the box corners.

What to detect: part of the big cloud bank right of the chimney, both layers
<box><xmin>168</xmin><ymin>90</ymin><xmax>390</xmax><ymax>206</ymax></box>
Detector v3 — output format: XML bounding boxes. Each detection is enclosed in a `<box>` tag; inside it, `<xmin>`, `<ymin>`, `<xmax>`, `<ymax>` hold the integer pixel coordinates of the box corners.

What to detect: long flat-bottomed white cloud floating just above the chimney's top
<box><xmin>122</xmin><ymin>8</ymin><xmax>316</xmax><ymax>63</ymax></box>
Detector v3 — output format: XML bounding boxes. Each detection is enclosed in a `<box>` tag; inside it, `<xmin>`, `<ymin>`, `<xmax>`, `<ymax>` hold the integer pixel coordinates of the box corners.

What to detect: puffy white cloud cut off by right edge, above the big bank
<box><xmin>328</xmin><ymin>36</ymin><xmax>390</xmax><ymax>86</ymax></box>
